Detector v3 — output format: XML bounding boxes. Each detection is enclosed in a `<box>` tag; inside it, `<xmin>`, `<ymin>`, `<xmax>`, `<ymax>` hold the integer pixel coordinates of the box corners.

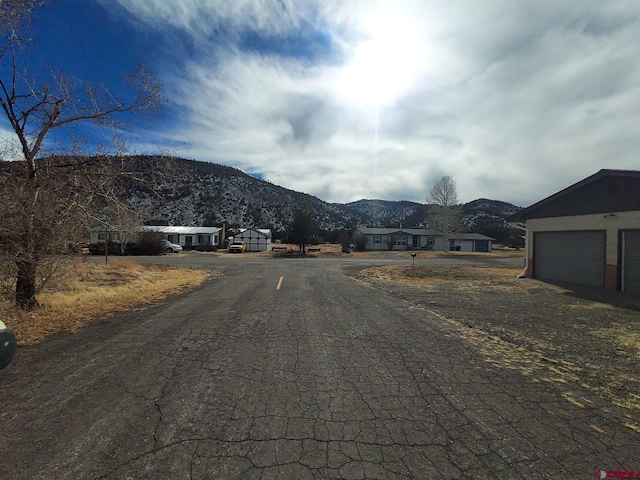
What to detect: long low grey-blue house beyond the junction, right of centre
<box><xmin>353</xmin><ymin>227</ymin><xmax>495</xmax><ymax>252</ymax></box>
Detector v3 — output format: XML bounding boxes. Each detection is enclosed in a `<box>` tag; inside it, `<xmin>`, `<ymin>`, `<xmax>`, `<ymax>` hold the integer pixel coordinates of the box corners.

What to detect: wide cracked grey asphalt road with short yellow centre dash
<box><xmin>0</xmin><ymin>255</ymin><xmax>640</xmax><ymax>479</ymax></box>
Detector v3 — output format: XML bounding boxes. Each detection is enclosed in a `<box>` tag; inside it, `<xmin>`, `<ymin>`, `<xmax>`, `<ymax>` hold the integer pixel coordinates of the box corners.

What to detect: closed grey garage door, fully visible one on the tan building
<box><xmin>533</xmin><ymin>231</ymin><xmax>606</xmax><ymax>288</ymax></box>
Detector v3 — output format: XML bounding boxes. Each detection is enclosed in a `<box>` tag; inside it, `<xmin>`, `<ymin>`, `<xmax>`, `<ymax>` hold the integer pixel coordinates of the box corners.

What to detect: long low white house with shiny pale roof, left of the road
<box><xmin>90</xmin><ymin>225</ymin><xmax>222</xmax><ymax>250</ymax></box>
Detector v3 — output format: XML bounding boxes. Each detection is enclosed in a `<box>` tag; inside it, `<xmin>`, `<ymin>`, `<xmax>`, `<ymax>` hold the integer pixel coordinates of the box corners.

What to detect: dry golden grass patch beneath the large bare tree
<box><xmin>0</xmin><ymin>259</ymin><xmax>211</xmax><ymax>345</ymax></box>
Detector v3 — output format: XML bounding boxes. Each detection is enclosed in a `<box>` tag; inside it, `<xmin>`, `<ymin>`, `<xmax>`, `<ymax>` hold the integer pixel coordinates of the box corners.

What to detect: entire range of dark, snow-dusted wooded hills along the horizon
<box><xmin>122</xmin><ymin>156</ymin><xmax>519</xmax><ymax>231</ymax></box>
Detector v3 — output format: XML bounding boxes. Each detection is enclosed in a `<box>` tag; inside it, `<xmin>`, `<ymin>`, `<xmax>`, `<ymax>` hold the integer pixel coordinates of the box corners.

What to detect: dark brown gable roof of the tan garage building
<box><xmin>507</xmin><ymin>169</ymin><xmax>640</xmax><ymax>222</ymax></box>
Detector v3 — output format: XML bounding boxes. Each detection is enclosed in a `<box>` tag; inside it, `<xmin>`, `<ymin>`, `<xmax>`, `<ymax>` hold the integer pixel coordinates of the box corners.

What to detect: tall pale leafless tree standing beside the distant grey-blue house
<box><xmin>427</xmin><ymin>175</ymin><xmax>461</xmax><ymax>250</ymax></box>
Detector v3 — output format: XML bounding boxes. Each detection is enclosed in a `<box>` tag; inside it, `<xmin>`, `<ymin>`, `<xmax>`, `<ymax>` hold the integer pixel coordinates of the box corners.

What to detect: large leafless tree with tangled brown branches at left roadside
<box><xmin>0</xmin><ymin>0</ymin><xmax>166</xmax><ymax>308</ymax></box>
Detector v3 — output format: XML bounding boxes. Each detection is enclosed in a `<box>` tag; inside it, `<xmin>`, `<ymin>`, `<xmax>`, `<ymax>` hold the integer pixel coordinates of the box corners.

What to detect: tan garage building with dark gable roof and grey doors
<box><xmin>507</xmin><ymin>169</ymin><xmax>640</xmax><ymax>293</ymax></box>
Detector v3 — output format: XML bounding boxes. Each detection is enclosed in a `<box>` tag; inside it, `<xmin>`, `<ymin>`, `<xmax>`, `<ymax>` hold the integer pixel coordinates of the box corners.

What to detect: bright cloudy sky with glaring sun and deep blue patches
<box><xmin>0</xmin><ymin>0</ymin><xmax>640</xmax><ymax>206</ymax></box>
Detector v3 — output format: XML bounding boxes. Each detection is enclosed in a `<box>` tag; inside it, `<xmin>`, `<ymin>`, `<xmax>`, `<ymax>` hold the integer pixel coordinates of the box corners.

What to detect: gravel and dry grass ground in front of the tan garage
<box><xmin>349</xmin><ymin>265</ymin><xmax>640</xmax><ymax>433</ymax></box>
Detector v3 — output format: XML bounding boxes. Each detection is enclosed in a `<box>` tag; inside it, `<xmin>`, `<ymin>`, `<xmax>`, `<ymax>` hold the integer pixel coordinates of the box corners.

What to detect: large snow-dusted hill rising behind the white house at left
<box><xmin>123</xmin><ymin>157</ymin><xmax>368</xmax><ymax>231</ymax></box>
